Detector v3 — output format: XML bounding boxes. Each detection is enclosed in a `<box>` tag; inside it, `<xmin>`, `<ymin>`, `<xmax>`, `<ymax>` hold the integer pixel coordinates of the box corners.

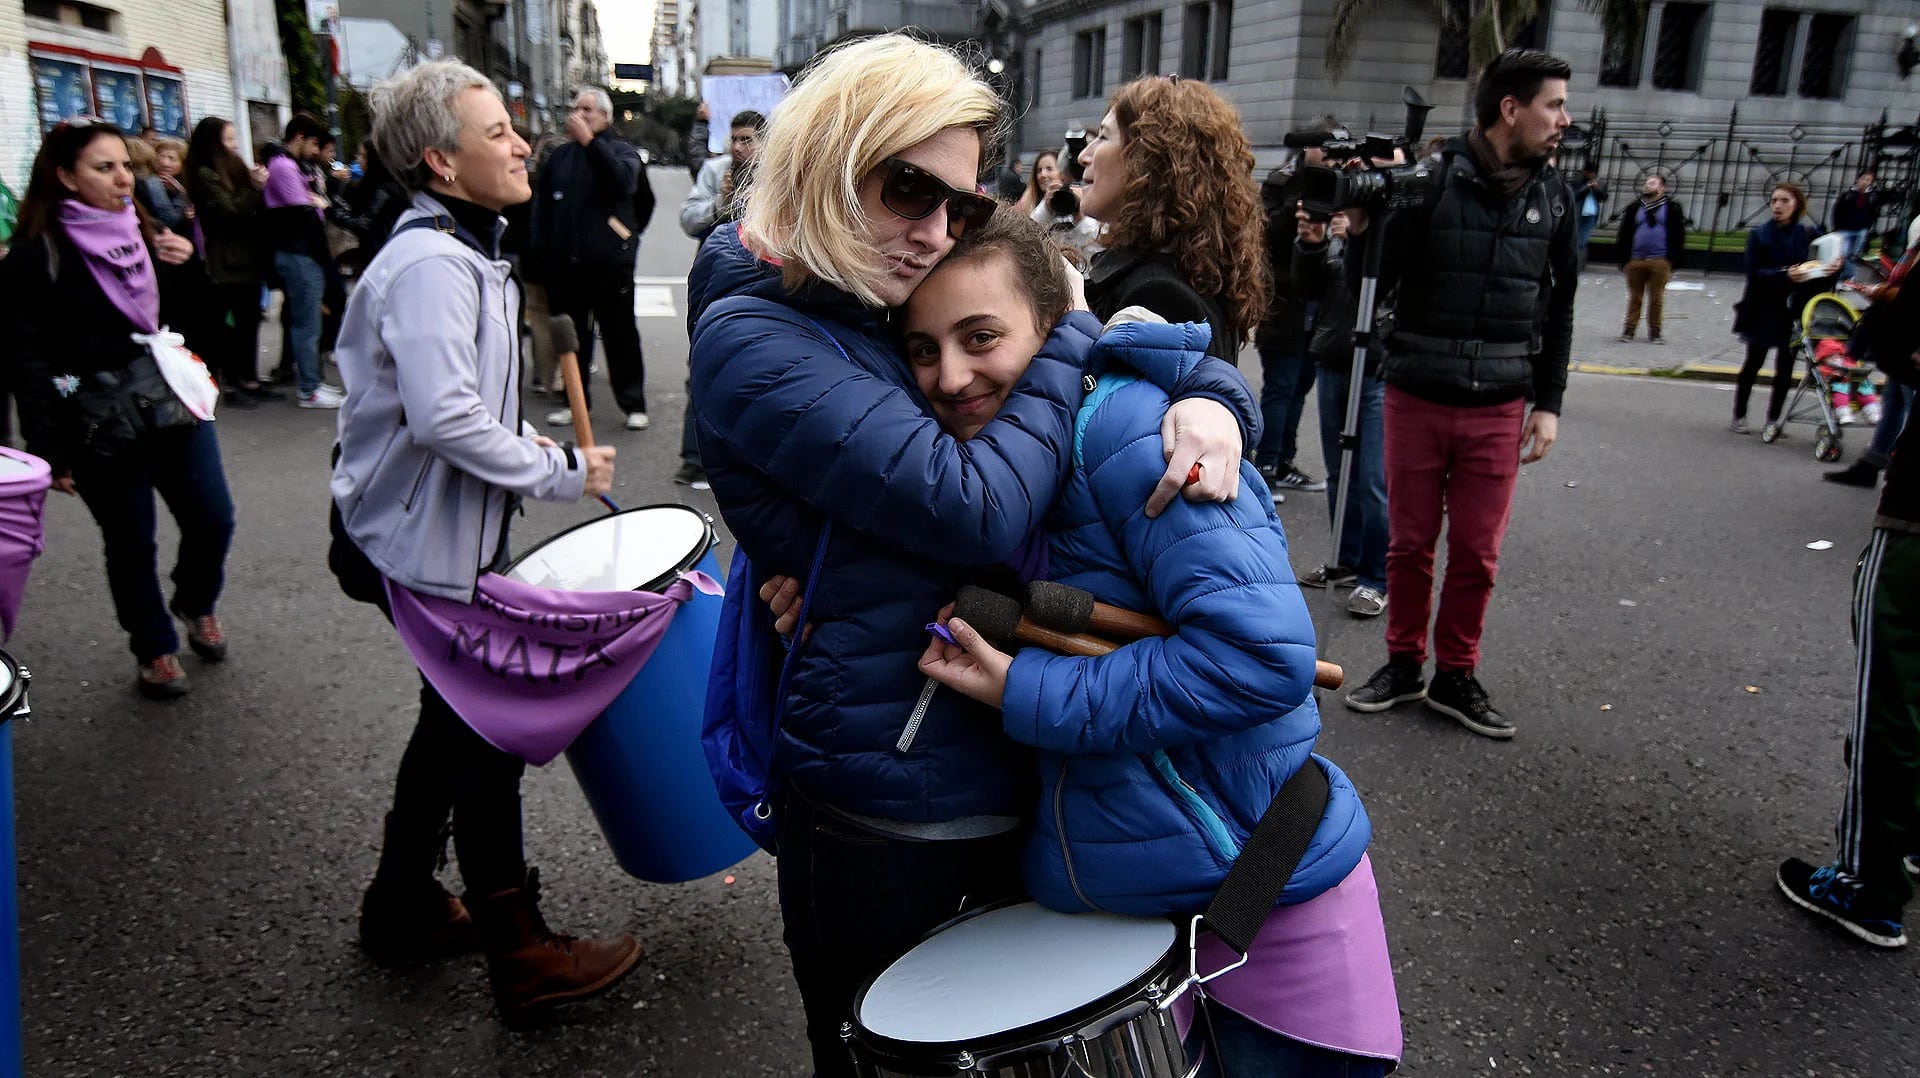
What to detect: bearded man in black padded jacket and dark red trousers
<box><xmin>1346</xmin><ymin>48</ymin><xmax>1578</xmax><ymax>738</ymax></box>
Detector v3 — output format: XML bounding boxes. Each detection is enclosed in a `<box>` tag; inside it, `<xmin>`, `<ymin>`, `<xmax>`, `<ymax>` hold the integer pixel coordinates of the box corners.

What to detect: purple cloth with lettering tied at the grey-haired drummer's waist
<box><xmin>386</xmin><ymin>571</ymin><xmax>720</xmax><ymax>765</ymax></box>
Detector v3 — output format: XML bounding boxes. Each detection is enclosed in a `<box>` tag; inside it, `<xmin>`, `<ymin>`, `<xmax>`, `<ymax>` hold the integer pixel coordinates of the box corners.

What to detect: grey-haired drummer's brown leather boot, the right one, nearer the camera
<box><xmin>467</xmin><ymin>869</ymin><xmax>639</xmax><ymax>1026</ymax></box>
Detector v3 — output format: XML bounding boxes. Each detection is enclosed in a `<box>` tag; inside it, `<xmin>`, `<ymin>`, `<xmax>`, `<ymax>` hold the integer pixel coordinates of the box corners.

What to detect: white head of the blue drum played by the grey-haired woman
<box><xmin>507</xmin><ymin>505</ymin><xmax>712</xmax><ymax>592</ymax></box>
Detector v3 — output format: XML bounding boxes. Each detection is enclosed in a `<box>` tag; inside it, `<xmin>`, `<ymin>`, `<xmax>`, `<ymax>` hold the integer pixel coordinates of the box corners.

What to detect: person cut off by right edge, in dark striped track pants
<box><xmin>1776</xmin><ymin>272</ymin><xmax>1920</xmax><ymax>947</ymax></box>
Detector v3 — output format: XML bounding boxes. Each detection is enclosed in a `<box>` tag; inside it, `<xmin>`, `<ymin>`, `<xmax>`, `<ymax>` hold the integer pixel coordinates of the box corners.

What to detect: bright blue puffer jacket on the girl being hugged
<box><xmin>1004</xmin><ymin>323</ymin><xmax>1373</xmax><ymax>917</ymax></box>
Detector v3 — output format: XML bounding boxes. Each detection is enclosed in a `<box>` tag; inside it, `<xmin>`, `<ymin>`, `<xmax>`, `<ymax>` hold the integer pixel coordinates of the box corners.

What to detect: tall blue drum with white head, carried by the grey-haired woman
<box><xmin>505</xmin><ymin>505</ymin><xmax>755</xmax><ymax>884</ymax></box>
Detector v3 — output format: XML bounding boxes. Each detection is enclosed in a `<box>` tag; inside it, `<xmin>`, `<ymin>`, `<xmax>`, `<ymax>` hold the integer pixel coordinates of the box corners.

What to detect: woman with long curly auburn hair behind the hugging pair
<box><xmin>1081</xmin><ymin>75</ymin><xmax>1271</xmax><ymax>363</ymax></box>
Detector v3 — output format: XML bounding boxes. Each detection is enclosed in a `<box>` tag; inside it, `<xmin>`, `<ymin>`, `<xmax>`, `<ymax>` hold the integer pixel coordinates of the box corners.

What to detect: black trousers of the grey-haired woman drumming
<box><xmin>378</xmin><ymin>676</ymin><xmax>526</xmax><ymax>895</ymax></box>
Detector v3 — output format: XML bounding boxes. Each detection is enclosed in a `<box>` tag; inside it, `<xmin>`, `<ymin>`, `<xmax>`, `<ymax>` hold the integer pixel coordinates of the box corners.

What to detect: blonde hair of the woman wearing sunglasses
<box><xmin>739</xmin><ymin>35</ymin><xmax>1004</xmax><ymax>307</ymax></box>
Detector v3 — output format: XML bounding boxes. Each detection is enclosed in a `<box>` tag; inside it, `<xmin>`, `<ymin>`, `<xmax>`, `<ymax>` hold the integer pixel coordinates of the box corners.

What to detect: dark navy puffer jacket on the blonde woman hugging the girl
<box><xmin>687</xmin><ymin>225</ymin><xmax>1258</xmax><ymax>822</ymax></box>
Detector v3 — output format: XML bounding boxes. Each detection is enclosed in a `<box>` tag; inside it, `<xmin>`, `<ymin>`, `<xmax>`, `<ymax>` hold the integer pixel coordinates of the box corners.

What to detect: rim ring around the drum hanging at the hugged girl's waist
<box><xmin>849</xmin><ymin>897</ymin><xmax>1187</xmax><ymax>1078</ymax></box>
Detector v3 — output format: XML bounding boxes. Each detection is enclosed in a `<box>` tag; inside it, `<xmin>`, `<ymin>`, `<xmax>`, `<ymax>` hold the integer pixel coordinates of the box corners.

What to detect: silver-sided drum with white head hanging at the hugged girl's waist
<box><xmin>841</xmin><ymin>901</ymin><xmax>1196</xmax><ymax>1078</ymax></box>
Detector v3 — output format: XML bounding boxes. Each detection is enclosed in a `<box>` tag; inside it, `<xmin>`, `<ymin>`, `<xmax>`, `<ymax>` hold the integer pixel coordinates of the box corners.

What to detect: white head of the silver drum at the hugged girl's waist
<box><xmin>858</xmin><ymin>901</ymin><xmax>1179</xmax><ymax>1043</ymax></box>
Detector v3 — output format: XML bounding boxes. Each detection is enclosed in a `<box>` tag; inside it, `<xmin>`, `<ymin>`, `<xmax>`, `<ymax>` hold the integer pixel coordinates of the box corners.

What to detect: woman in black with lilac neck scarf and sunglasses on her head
<box><xmin>0</xmin><ymin>121</ymin><xmax>234</xmax><ymax>699</ymax></box>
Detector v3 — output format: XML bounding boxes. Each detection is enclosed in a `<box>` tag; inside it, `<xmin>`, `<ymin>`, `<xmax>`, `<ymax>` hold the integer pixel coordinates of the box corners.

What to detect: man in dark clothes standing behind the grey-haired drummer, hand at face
<box><xmin>530</xmin><ymin>90</ymin><xmax>651</xmax><ymax>430</ymax></box>
